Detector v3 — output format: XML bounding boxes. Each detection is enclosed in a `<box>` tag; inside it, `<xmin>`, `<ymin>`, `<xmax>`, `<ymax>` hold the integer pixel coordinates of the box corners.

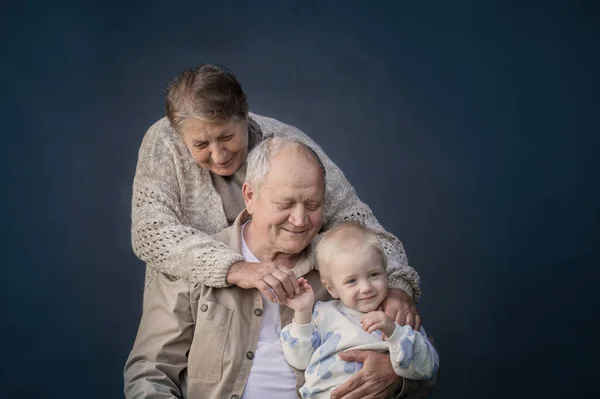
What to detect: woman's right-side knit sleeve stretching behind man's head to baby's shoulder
<box><xmin>257</xmin><ymin>117</ymin><xmax>421</xmax><ymax>303</ymax></box>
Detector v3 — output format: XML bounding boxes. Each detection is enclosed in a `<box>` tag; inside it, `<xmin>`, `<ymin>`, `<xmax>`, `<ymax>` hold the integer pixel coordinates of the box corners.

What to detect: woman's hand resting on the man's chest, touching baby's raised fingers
<box><xmin>226</xmin><ymin>262</ymin><xmax>300</xmax><ymax>305</ymax></box>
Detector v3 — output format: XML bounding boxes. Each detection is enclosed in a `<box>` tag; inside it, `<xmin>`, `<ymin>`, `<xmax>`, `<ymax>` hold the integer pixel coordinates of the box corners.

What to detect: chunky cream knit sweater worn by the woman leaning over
<box><xmin>131</xmin><ymin>113</ymin><xmax>421</xmax><ymax>302</ymax></box>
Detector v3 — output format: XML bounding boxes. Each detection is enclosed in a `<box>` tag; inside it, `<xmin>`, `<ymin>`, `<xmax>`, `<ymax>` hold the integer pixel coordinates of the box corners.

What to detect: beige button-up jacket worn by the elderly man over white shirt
<box><xmin>125</xmin><ymin>211</ymin><xmax>332</xmax><ymax>399</ymax></box>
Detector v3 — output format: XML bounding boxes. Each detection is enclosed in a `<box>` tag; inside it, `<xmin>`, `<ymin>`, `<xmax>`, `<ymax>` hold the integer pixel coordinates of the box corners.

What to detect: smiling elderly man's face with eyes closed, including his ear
<box><xmin>243</xmin><ymin>149</ymin><xmax>325</xmax><ymax>254</ymax></box>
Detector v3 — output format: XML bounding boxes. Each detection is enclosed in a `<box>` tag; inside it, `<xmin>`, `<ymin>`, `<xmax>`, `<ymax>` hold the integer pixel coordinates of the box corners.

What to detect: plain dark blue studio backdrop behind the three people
<box><xmin>0</xmin><ymin>0</ymin><xmax>600</xmax><ymax>398</ymax></box>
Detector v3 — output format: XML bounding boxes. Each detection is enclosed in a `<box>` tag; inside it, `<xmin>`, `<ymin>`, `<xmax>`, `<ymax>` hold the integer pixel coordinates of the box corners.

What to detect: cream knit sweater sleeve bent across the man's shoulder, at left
<box><xmin>131</xmin><ymin>122</ymin><xmax>244</xmax><ymax>287</ymax></box>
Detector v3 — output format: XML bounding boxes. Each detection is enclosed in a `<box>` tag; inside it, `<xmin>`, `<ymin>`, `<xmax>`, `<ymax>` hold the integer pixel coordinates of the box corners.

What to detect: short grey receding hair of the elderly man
<box><xmin>246</xmin><ymin>137</ymin><xmax>325</xmax><ymax>192</ymax></box>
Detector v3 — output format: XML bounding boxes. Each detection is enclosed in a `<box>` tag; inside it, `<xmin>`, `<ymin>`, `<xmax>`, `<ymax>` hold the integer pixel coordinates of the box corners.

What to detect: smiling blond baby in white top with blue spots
<box><xmin>281</xmin><ymin>223</ymin><xmax>439</xmax><ymax>398</ymax></box>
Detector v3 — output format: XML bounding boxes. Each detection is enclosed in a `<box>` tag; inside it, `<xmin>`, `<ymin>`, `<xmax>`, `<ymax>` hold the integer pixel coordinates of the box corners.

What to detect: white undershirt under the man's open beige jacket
<box><xmin>240</xmin><ymin>223</ymin><xmax>297</xmax><ymax>399</ymax></box>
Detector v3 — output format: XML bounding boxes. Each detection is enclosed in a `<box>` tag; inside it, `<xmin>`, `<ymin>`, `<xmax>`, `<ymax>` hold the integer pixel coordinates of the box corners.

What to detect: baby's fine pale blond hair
<box><xmin>316</xmin><ymin>222</ymin><xmax>387</xmax><ymax>282</ymax></box>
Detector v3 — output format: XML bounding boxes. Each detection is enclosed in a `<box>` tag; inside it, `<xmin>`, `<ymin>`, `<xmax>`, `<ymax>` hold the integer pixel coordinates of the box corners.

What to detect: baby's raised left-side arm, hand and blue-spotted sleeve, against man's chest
<box><xmin>281</xmin><ymin>277</ymin><xmax>321</xmax><ymax>370</ymax></box>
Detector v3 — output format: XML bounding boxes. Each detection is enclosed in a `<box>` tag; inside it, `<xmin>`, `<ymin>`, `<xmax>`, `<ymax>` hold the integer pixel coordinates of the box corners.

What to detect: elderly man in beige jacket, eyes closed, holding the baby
<box><xmin>125</xmin><ymin>138</ymin><xmax>434</xmax><ymax>399</ymax></box>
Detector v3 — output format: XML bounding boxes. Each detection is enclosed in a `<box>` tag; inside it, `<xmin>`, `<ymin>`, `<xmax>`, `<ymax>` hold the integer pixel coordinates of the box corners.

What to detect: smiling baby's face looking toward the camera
<box><xmin>325</xmin><ymin>250</ymin><xmax>387</xmax><ymax>313</ymax></box>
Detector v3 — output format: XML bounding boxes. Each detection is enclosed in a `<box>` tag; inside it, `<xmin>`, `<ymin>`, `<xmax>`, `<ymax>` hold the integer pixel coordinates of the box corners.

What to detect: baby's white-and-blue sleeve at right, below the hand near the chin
<box><xmin>388</xmin><ymin>325</ymin><xmax>440</xmax><ymax>380</ymax></box>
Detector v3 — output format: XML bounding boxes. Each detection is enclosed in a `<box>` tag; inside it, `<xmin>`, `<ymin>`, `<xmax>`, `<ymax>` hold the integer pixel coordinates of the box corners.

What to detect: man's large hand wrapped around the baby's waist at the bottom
<box><xmin>331</xmin><ymin>350</ymin><xmax>402</xmax><ymax>399</ymax></box>
